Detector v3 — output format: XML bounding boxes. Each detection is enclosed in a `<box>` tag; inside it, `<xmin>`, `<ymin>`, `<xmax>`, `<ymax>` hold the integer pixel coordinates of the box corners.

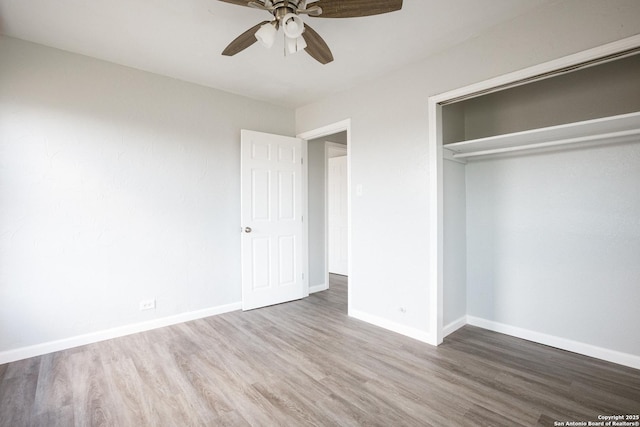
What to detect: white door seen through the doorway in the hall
<box><xmin>328</xmin><ymin>156</ymin><xmax>349</xmax><ymax>276</ymax></box>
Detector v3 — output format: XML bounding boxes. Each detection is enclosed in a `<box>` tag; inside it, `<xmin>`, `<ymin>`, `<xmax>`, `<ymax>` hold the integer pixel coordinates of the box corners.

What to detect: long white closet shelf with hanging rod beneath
<box><xmin>443</xmin><ymin>112</ymin><xmax>640</xmax><ymax>159</ymax></box>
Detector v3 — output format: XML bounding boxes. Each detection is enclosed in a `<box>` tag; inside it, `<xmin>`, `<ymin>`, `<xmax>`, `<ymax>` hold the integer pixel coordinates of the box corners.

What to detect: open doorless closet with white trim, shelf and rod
<box><xmin>429</xmin><ymin>36</ymin><xmax>640</xmax><ymax>367</ymax></box>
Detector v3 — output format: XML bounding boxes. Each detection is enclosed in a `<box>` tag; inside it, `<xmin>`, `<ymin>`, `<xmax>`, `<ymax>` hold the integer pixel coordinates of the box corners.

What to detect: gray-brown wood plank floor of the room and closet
<box><xmin>0</xmin><ymin>276</ymin><xmax>640</xmax><ymax>427</ymax></box>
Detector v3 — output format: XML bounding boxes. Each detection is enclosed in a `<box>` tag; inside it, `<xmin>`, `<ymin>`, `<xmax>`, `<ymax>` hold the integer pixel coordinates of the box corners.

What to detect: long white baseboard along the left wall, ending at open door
<box><xmin>0</xmin><ymin>302</ymin><xmax>242</xmax><ymax>365</ymax></box>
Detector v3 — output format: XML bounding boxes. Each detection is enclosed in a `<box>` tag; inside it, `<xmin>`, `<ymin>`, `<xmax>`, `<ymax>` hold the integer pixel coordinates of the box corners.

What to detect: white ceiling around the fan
<box><xmin>0</xmin><ymin>0</ymin><xmax>550</xmax><ymax>107</ymax></box>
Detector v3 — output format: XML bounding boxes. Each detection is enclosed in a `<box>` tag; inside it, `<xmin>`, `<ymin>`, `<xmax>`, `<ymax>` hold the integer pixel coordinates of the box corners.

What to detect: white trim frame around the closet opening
<box><xmin>428</xmin><ymin>35</ymin><xmax>640</xmax><ymax>345</ymax></box>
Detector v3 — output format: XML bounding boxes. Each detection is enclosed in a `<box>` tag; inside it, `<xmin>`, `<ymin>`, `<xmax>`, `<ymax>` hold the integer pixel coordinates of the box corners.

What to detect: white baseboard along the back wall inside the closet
<box><xmin>467</xmin><ymin>316</ymin><xmax>640</xmax><ymax>369</ymax></box>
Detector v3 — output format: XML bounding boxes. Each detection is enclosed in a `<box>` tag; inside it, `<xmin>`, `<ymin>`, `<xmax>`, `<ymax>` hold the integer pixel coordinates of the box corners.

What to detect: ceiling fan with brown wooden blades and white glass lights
<box><xmin>220</xmin><ymin>0</ymin><xmax>402</xmax><ymax>64</ymax></box>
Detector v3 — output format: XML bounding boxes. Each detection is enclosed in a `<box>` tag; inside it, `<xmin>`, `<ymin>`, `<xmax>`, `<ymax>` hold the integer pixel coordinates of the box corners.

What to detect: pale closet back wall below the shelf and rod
<box><xmin>466</xmin><ymin>139</ymin><xmax>640</xmax><ymax>356</ymax></box>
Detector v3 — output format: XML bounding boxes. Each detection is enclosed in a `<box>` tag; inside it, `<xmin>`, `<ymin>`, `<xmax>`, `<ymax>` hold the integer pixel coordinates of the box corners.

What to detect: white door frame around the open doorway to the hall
<box><xmin>296</xmin><ymin>118</ymin><xmax>352</xmax><ymax>316</ymax></box>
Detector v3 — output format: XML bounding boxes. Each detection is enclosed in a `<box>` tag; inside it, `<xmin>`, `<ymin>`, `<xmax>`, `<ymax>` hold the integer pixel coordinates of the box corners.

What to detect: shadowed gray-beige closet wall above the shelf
<box><xmin>443</xmin><ymin>54</ymin><xmax>640</xmax><ymax>143</ymax></box>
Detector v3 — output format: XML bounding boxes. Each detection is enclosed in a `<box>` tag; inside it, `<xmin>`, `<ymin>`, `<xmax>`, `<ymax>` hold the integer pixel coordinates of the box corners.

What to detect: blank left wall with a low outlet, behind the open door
<box><xmin>0</xmin><ymin>37</ymin><xmax>294</xmax><ymax>363</ymax></box>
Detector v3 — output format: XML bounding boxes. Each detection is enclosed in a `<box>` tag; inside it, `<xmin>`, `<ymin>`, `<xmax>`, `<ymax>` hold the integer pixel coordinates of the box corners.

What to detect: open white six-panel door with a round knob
<box><xmin>241</xmin><ymin>130</ymin><xmax>305</xmax><ymax>310</ymax></box>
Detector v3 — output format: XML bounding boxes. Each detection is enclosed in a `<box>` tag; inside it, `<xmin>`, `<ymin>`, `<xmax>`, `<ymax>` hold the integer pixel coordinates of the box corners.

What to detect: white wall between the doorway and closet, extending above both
<box><xmin>296</xmin><ymin>0</ymin><xmax>640</xmax><ymax>339</ymax></box>
